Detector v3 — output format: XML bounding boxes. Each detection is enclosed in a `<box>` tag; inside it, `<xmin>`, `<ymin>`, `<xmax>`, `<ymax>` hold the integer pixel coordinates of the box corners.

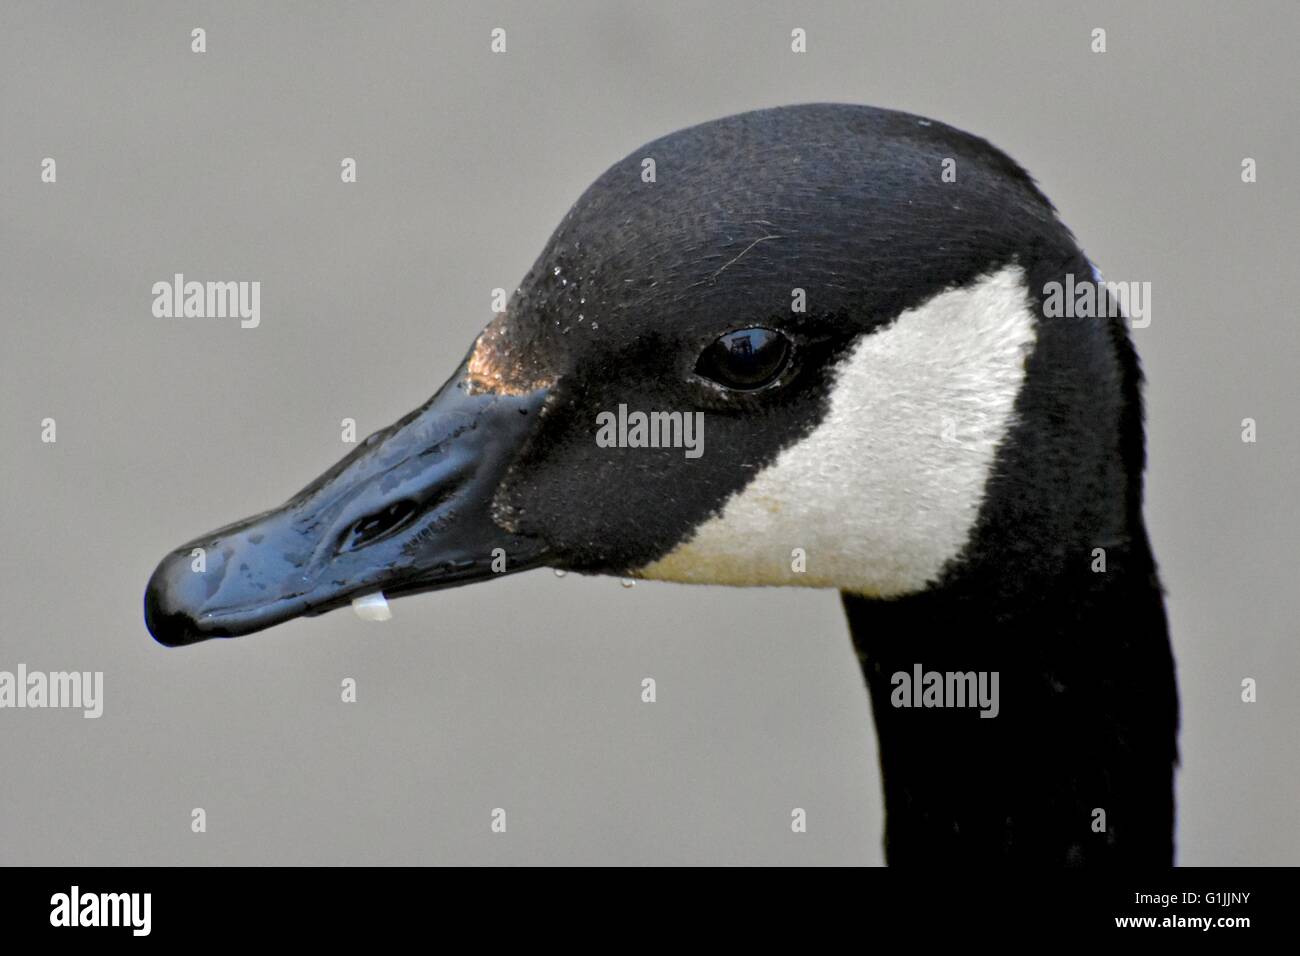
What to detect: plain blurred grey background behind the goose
<box><xmin>0</xmin><ymin>0</ymin><xmax>1300</xmax><ymax>864</ymax></box>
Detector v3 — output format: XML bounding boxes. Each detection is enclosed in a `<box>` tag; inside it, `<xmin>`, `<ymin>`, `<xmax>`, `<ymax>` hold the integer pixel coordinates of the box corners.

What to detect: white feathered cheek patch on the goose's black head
<box><xmin>638</xmin><ymin>267</ymin><xmax>1035</xmax><ymax>597</ymax></box>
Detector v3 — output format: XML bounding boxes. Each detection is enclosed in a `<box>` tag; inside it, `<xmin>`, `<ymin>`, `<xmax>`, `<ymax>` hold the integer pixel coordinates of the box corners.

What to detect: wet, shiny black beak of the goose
<box><xmin>144</xmin><ymin>365</ymin><xmax>546</xmax><ymax>646</ymax></box>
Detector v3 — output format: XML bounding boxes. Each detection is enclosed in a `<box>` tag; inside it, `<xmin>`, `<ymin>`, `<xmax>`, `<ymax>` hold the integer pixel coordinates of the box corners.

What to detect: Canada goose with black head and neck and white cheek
<box><xmin>144</xmin><ymin>104</ymin><xmax>1178</xmax><ymax>865</ymax></box>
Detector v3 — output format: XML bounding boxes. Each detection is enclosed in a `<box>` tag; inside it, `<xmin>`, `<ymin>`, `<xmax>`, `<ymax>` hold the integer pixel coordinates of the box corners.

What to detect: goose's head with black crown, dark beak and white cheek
<box><xmin>144</xmin><ymin>105</ymin><xmax>1121</xmax><ymax>645</ymax></box>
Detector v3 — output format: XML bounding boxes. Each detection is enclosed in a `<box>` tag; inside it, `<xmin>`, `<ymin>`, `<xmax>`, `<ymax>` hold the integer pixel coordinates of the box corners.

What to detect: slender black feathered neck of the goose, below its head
<box><xmin>844</xmin><ymin>530</ymin><xmax>1178</xmax><ymax>866</ymax></box>
